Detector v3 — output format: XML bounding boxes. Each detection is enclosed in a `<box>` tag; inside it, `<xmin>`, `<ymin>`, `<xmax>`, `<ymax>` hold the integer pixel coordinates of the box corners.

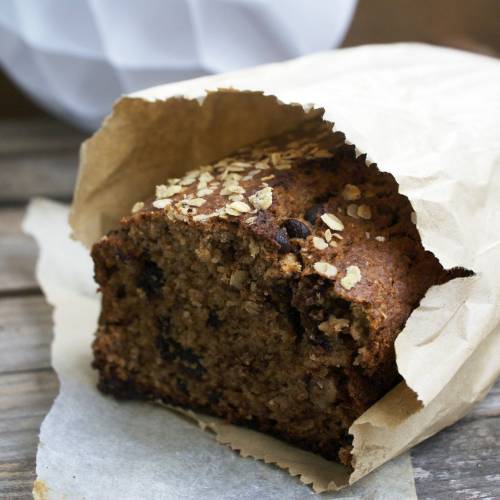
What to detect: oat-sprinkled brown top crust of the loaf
<box><xmin>125</xmin><ymin>124</ymin><xmax>449</xmax><ymax>373</ymax></box>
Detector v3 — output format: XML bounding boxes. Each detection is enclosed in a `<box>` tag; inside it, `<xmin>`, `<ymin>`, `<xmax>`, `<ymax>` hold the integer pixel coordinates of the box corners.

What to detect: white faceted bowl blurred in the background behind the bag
<box><xmin>0</xmin><ymin>0</ymin><xmax>356</xmax><ymax>130</ymax></box>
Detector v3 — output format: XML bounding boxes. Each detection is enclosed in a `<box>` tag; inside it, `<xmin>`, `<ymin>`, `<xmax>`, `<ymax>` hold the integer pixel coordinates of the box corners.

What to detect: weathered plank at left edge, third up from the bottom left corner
<box><xmin>0</xmin><ymin>208</ymin><xmax>38</xmax><ymax>294</ymax></box>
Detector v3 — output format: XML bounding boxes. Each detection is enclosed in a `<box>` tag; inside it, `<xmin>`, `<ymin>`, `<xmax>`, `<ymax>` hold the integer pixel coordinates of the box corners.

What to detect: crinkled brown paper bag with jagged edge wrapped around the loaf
<box><xmin>29</xmin><ymin>44</ymin><xmax>500</xmax><ymax>498</ymax></box>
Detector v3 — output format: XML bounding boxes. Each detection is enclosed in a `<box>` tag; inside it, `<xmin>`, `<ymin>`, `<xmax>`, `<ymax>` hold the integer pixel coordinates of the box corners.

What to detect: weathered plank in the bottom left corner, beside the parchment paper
<box><xmin>0</xmin><ymin>369</ymin><xmax>59</xmax><ymax>499</ymax></box>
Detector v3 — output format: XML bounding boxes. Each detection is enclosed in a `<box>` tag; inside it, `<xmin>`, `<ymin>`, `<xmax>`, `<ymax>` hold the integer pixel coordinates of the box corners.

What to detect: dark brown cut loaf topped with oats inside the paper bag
<box><xmin>92</xmin><ymin>120</ymin><xmax>458</xmax><ymax>464</ymax></box>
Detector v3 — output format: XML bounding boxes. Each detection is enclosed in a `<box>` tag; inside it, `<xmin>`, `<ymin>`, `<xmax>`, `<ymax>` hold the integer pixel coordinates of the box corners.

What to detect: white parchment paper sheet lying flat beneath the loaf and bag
<box><xmin>25</xmin><ymin>200</ymin><xmax>416</xmax><ymax>500</ymax></box>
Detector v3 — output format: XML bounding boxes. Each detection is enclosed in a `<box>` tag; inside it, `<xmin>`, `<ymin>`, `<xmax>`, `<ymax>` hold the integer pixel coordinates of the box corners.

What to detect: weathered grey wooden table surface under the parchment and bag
<box><xmin>0</xmin><ymin>117</ymin><xmax>500</xmax><ymax>499</ymax></box>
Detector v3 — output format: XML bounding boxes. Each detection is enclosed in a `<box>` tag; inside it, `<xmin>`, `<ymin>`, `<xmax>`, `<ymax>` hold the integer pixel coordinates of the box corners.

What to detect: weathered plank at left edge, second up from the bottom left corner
<box><xmin>0</xmin><ymin>295</ymin><xmax>52</xmax><ymax>375</ymax></box>
